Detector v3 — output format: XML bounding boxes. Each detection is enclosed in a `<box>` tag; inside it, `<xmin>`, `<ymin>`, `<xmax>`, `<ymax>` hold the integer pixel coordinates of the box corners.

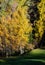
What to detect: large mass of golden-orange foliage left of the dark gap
<box><xmin>0</xmin><ymin>0</ymin><xmax>32</xmax><ymax>51</ymax></box>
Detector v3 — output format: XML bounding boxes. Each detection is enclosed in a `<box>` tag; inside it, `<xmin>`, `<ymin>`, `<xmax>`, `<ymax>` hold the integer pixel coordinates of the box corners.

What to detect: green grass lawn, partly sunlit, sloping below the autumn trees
<box><xmin>0</xmin><ymin>49</ymin><xmax>45</xmax><ymax>65</ymax></box>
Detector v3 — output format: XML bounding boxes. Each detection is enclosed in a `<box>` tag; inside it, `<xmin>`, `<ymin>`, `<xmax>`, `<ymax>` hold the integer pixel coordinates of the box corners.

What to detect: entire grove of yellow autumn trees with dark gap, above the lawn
<box><xmin>0</xmin><ymin>0</ymin><xmax>45</xmax><ymax>56</ymax></box>
